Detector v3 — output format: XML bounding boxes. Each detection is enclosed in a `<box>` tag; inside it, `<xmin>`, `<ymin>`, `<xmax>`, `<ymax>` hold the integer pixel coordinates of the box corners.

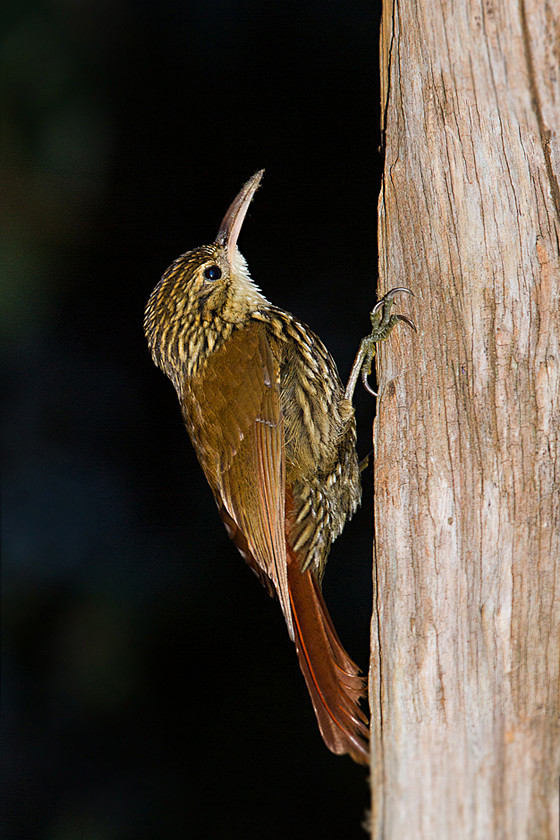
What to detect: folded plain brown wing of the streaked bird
<box><xmin>190</xmin><ymin>324</ymin><xmax>293</xmax><ymax>639</ymax></box>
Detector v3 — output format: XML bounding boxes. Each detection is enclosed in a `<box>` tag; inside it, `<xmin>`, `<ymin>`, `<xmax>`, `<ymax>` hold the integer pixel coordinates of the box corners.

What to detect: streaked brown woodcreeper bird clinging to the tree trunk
<box><xmin>144</xmin><ymin>171</ymin><xmax>413</xmax><ymax>764</ymax></box>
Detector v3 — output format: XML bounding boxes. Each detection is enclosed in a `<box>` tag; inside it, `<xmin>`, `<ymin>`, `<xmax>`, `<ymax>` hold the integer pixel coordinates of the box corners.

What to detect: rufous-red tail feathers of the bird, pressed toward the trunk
<box><xmin>287</xmin><ymin>550</ymin><xmax>369</xmax><ymax>764</ymax></box>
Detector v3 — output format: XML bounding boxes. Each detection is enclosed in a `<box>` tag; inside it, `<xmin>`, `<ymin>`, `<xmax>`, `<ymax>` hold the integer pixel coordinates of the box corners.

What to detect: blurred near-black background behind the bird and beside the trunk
<box><xmin>0</xmin><ymin>0</ymin><xmax>381</xmax><ymax>840</ymax></box>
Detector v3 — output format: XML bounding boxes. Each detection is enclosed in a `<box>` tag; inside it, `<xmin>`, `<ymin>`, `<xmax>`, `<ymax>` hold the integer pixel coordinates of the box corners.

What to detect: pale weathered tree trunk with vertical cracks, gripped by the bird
<box><xmin>370</xmin><ymin>0</ymin><xmax>560</xmax><ymax>840</ymax></box>
